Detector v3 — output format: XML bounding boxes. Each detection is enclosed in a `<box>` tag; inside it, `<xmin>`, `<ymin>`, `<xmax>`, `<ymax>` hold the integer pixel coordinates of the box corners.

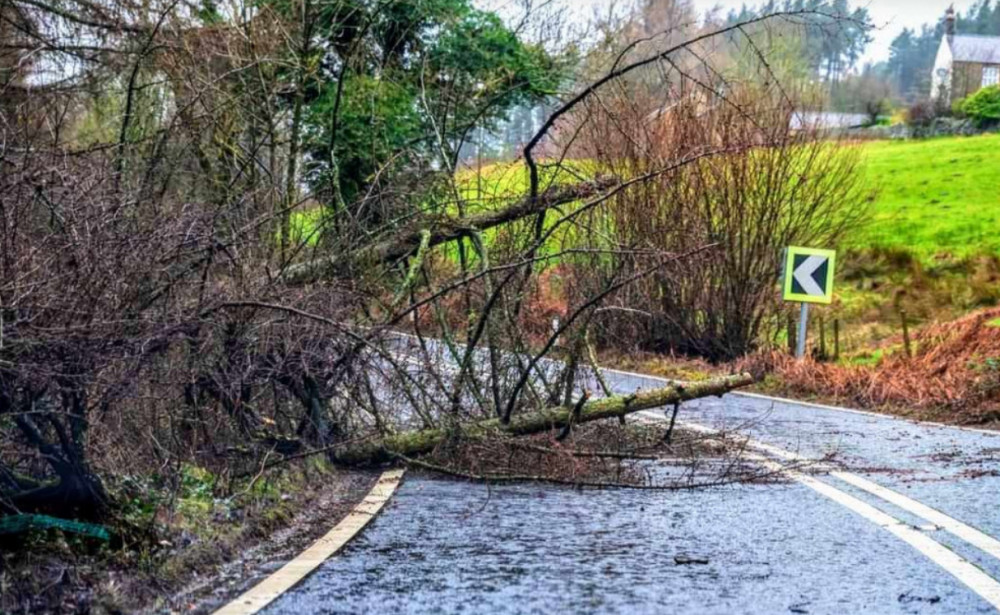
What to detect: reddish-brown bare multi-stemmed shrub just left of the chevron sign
<box><xmin>564</xmin><ymin>84</ymin><xmax>869</xmax><ymax>361</ymax></box>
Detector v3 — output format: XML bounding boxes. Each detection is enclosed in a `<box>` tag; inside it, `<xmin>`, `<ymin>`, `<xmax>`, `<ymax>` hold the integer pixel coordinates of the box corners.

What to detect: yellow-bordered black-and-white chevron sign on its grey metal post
<box><xmin>782</xmin><ymin>246</ymin><xmax>837</xmax><ymax>359</ymax></box>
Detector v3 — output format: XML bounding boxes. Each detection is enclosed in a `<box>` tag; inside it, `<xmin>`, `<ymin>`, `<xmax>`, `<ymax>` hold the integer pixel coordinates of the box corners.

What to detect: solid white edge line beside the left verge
<box><xmin>214</xmin><ymin>470</ymin><xmax>403</xmax><ymax>615</ymax></box>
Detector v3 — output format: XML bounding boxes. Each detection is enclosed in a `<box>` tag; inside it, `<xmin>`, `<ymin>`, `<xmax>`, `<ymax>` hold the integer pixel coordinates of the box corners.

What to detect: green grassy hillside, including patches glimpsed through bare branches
<box><xmin>293</xmin><ymin>135</ymin><xmax>1000</xmax><ymax>351</ymax></box>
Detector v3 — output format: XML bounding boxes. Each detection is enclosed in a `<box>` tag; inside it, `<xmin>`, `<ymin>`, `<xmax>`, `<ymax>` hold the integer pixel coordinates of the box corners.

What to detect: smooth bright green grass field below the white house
<box><xmin>843</xmin><ymin>135</ymin><xmax>1000</xmax><ymax>260</ymax></box>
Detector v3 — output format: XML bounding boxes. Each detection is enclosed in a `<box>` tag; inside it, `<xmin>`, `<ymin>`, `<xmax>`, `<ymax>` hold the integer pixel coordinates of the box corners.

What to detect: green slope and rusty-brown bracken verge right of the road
<box><xmin>605</xmin><ymin>134</ymin><xmax>1000</xmax><ymax>426</ymax></box>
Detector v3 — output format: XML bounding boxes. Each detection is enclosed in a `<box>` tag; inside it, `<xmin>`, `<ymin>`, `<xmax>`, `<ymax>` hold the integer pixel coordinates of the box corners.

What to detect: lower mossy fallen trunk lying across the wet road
<box><xmin>332</xmin><ymin>374</ymin><xmax>754</xmax><ymax>465</ymax></box>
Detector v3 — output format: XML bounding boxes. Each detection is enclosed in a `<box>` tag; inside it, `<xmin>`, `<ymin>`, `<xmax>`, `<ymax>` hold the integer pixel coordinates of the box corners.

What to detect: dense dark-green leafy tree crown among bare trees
<box><xmin>290</xmin><ymin>0</ymin><xmax>566</xmax><ymax>224</ymax></box>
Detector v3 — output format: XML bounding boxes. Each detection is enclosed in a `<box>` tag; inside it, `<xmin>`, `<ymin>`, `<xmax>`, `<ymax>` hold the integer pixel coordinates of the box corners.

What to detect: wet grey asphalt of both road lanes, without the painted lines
<box><xmin>266</xmin><ymin>374</ymin><xmax>1000</xmax><ymax>614</ymax></box>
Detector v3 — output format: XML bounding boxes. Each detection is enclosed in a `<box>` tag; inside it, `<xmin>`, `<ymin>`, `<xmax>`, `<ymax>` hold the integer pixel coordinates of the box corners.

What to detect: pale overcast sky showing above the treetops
<box><xmin>496</xmin><ymin>0</ymin><xmax>980</xmax><ymax>67</ymax></box>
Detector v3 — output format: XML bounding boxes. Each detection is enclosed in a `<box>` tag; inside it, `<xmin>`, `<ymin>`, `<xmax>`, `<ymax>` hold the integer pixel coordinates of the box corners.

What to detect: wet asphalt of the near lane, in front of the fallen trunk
<box><xmin>268</xmin><ymin>477</ymin><xmax>990</xmax><ymax>615</ymax></box>
